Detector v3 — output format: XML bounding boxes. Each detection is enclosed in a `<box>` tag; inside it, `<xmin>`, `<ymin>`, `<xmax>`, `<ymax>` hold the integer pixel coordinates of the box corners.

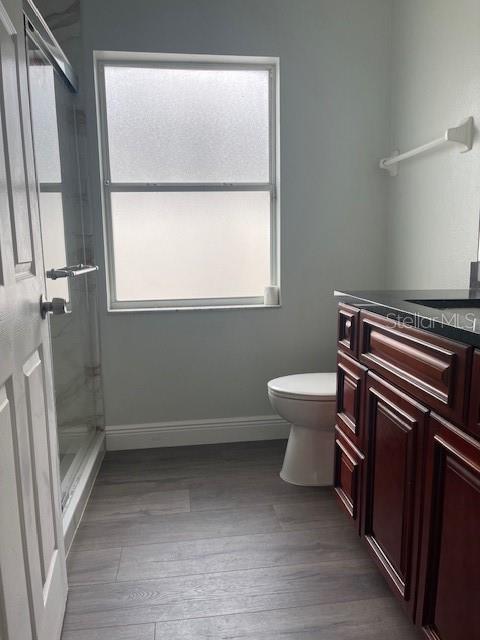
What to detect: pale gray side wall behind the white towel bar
<box><xmin>388</xmin><ymin>0</ymin><xmax>480</xmax><ymax>288</ymax></box>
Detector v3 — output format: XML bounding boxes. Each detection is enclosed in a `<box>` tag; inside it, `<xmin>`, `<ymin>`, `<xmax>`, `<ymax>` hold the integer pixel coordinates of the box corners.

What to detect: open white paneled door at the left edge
<box><xmin>0</xmin><ymin>0</ymin><xmax>67</xmax><ymax>640</ymax></box>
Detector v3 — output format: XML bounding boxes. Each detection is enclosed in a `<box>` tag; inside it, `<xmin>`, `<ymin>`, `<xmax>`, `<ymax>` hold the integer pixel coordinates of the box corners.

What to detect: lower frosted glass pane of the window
<box><xmin>112</xmin><ymin>191</ymin><xmax>270</xmax><ymax>300</ymax></box>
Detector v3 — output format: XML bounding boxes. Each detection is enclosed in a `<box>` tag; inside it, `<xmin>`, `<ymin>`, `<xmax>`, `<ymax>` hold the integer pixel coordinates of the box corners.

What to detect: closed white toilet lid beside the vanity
<box><xmin>268</xmin><ymin>373</ymin><xmax>337</xmax><ymax>400</ymax></box>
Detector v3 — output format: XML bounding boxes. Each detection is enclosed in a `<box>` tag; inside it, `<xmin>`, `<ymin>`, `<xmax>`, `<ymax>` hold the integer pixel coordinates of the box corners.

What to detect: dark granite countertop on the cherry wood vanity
<box><xmin>335</xmin><ymin>289</ymin><xmax>480</xmax><ymax>348</ymax></box>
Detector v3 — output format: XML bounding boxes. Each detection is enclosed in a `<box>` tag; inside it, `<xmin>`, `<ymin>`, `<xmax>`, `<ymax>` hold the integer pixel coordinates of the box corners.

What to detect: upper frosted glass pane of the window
<box><xmin>104</xmin><ymin>66</ymin><xmax>270</xmax><ymax>183</ymax></box>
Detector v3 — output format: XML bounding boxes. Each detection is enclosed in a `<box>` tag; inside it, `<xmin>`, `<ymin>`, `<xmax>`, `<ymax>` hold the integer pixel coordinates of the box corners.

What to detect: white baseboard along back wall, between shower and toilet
<box><xmin>105</xmin><ymin>415</ymin><xmax>290</xmax><ymax>451</ymax></box>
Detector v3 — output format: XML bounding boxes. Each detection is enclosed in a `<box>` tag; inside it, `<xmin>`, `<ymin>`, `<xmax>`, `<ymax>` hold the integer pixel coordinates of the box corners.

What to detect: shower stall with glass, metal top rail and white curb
<box><xmin>24</xmin><ymin>2</ymin><xmax>103</xmax><ymax>548</ymax></box>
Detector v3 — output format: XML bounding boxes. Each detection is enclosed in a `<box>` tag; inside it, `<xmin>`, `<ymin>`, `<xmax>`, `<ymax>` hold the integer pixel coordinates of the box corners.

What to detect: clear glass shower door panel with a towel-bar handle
<box><xmin>27</xmin><ymin>21</ymin><xmax>98</xmax><ymax>507</ymax></box>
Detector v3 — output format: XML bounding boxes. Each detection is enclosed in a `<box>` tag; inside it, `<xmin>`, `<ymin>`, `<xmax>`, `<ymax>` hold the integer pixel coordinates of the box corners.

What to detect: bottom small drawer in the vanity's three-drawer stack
<box><xmin>333</xmin><ymin>427</ymin><xmax>363</xmax><ymax>533</ymax></box>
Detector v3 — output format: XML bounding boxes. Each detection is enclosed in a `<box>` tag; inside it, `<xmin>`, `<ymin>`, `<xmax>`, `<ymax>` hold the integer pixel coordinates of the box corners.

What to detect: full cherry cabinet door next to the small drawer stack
<box><xmin>362</xmin><ymin>373</ymin><xmax>428</xmax><ymax>619</ymax></box>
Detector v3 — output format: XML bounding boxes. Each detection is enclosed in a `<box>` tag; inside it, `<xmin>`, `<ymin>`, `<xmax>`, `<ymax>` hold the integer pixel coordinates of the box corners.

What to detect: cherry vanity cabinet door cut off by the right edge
<box><xmin>417</xmin><ymin>415</ymin><xmax>480</xmax><ymax>640</ymax></box>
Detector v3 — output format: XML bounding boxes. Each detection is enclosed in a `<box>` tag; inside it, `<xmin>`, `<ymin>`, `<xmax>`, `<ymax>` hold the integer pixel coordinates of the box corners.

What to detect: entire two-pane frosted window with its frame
<box><xmin>97</xmin><ymin>54</ymin><xmax>278</xmax><ymax>309</ymax></box>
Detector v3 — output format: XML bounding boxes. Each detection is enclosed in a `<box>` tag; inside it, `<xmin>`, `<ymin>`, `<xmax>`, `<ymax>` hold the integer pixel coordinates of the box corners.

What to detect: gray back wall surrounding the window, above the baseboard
<box><xmin>82</xmin><ymin>0</ymin><xmax>391</xmax><ymax>425</ymax></box>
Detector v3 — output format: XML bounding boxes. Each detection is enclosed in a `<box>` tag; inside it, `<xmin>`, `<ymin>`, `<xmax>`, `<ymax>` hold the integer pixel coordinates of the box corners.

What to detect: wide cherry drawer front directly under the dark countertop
<box><xmin>359</xmin><ymin>311</ymin><xmax>472</xmax><ymax>422</ymax></box>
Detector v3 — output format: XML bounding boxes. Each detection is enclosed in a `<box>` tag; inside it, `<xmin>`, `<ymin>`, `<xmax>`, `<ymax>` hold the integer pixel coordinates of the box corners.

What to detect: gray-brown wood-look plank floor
<box><xmin>62</xmin><ymin>441</ymin><xmax>420</xmax><ymax>640</ymax></box>
